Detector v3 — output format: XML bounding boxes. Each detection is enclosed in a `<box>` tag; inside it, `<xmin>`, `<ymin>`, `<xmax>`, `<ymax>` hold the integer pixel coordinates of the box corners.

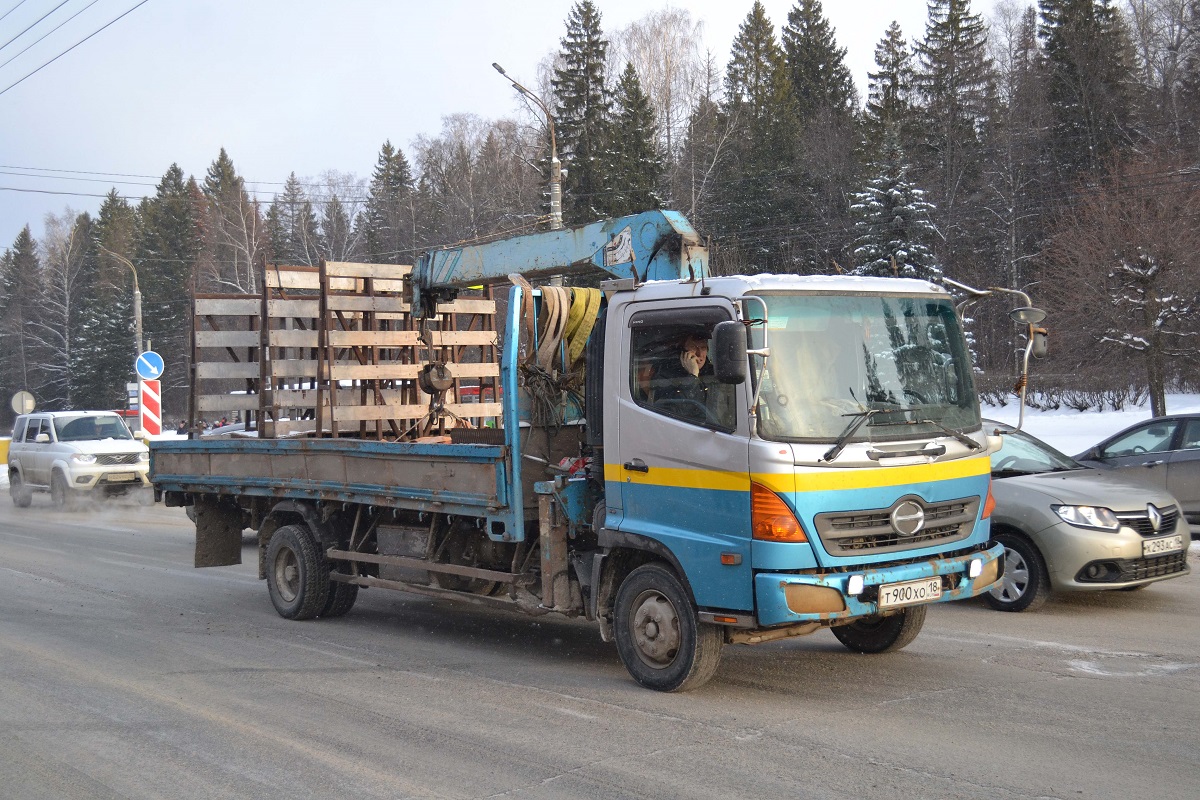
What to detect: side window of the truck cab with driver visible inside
<box><xmin>629</xmin><ymin>323</ymin><xmax>737</xmax><ymax>431</ymax></box>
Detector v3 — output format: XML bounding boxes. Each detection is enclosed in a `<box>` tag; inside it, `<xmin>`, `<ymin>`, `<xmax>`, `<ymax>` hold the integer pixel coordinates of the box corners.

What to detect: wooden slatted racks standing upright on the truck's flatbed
<box><xmin>192</xmin><ymin>261</ymin><xmax>500</xmax><ymax>440</ymax></box>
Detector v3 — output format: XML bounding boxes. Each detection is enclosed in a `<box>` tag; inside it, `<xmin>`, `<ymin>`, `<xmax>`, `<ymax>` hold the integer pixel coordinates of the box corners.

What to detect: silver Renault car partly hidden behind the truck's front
<box><xmin>984</xmin><ymin>420</ymin><xmax>1190</xmax><ymax>612</ymax></box>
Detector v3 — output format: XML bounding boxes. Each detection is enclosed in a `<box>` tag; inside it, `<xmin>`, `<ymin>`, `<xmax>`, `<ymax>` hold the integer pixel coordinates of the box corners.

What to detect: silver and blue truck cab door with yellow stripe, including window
<box><xmin>608</xmin><ymin>300</ymin><xmax>754</xmax><ymax>610</ymax></box>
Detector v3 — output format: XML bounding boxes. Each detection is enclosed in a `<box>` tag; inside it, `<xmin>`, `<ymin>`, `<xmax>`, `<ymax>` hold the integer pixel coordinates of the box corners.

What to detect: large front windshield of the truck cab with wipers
<box><xmin>748</xmin><ymin>293</ymin><xmax>980</xmax><ymax>441</ymax></box>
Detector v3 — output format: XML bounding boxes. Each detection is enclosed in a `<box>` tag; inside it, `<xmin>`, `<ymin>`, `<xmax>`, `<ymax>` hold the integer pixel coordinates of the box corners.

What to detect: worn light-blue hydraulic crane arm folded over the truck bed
<box><xmin>413</xmin><ymin>211</ymin><xmax>708</xmax><ymax>306</ymax></box>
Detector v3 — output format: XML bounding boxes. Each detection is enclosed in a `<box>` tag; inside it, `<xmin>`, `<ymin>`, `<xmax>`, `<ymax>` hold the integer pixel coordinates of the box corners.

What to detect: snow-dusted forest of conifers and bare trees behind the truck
<box><xmin>0</xmin><ymin>0</ymin><xmax>1200</xmax><ymax>419</ymax></box>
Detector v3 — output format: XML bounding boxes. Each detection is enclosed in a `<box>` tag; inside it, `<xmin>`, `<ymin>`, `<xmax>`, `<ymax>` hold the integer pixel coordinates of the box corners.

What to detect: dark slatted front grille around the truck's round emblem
<box><xmin>814</xmin><ymin>495</ymin><xmax>979</xmax><ymax>555</ymax></box>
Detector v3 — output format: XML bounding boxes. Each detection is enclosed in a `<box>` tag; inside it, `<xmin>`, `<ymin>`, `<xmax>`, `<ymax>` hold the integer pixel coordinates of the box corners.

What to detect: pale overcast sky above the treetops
<box><xmin>0</xmin><ymin>0</ymin><xmax>994</xmax><ymax>248</ymax></box>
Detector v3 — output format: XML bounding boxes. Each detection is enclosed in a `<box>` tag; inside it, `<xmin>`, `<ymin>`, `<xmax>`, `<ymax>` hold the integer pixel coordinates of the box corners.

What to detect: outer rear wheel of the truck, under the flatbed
<box><xmin>266</xmin><ymin>525</ymin><xmax>329</xmax><ymax>619</ymax></box>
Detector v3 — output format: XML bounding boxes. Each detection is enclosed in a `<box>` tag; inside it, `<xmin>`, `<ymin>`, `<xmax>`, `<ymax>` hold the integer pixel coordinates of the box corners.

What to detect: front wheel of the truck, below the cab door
<box><xmin>614</xmin><ymin>564</ymin><xmax>725</xmax><ymax>692</ymax></box>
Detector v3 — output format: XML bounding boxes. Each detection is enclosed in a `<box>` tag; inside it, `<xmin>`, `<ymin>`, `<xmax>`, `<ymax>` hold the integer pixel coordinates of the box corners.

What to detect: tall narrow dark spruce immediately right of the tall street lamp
<box><xmin>551</xmin><ymin>0</ymin><xmax>612</xmax><ymax>224</ymax></box>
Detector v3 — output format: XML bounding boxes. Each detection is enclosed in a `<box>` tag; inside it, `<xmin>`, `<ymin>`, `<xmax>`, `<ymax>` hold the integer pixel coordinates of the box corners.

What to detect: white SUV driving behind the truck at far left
<box><xmin>8</xmin><ymin>411</ymin><xmax>150</xmax><ymax>509</ymax></box>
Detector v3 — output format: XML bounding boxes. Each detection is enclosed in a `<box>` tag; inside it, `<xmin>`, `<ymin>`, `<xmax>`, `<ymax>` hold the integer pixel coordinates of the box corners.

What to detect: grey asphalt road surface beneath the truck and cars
<box><xmin>0</xmin><ymin>497</ymin><xmax>1200</xmax><ymax>800</ymax></box>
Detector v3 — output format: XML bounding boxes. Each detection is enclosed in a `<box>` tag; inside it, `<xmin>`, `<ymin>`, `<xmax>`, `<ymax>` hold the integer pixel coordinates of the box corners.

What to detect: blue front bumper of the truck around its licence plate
<box><xmin>755</xmin><ymin>545</ymin><xmax>1004</xmax><ymax>626</ymax></box>
